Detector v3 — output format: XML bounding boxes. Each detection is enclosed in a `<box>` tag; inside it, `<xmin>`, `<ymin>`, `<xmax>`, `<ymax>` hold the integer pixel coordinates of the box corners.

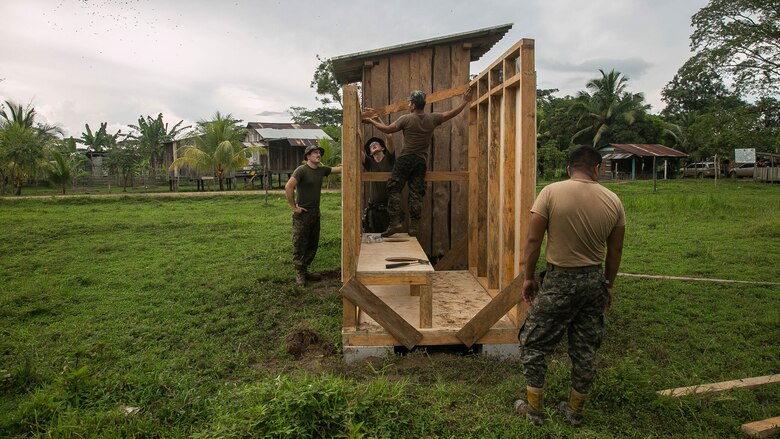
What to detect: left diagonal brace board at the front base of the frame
<box><xmin>341</xmin><ymin>279</ymin><xmax>422</xmax><ymax>349</ymax></box>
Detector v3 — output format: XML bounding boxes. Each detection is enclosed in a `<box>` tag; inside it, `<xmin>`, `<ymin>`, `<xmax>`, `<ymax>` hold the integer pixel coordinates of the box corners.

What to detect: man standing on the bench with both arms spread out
<box><xmin>363</xmin><ymin>88</ymin><xmax>471</xmax><ymax>237</ymax></box>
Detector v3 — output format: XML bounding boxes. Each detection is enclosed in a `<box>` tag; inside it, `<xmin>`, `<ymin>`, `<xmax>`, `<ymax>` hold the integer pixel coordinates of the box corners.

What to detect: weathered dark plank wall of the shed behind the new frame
<box><xmin>363</xmin><ymin>44</ymin><xmax>470</xmax><ymax>260</ymax></box>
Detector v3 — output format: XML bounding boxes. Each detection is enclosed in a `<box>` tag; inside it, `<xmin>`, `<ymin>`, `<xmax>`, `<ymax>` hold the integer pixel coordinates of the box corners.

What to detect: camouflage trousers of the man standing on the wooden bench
<box><xmin>387</xmin><ymin>154</ymin><xmax>427</xmax><ymax>224</ymax></box>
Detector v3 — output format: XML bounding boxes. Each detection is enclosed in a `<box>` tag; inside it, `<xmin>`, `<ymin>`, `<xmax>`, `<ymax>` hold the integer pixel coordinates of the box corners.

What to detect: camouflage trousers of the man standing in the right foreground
<box><xmin>518</xmin><ymin>269</ymin><xmax>608</xmax><ymax>393</ymax></box>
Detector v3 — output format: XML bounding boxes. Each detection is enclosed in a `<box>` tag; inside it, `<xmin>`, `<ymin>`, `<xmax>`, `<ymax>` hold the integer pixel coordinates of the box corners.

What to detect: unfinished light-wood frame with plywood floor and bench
<box><xmin>341</xmin><ymin>31</ymin><xmax>536</xmax><ymax>354</ymax></box>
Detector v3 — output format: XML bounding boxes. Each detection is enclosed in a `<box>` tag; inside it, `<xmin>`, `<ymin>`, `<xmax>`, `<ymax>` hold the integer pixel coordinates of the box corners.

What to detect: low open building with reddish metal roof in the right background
<box><xmin>599</xmin><ymin>143</ymin><xmax>688</xmax><ymax>180</ymax></box>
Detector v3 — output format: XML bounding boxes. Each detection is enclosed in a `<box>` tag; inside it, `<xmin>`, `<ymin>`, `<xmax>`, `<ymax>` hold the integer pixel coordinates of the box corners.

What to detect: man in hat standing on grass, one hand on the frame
<box><xmin>284</xmin><ymin>145</ymin><xmax>341</xmax><ymax>286</ymax></box>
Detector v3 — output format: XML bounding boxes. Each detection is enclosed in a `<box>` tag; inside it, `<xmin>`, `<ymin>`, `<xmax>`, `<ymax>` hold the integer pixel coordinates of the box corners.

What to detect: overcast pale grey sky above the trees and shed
<box><xmin>0</xmin><ymin>0</ymin><xmax>707</xmax><ymax>137</ymax></box>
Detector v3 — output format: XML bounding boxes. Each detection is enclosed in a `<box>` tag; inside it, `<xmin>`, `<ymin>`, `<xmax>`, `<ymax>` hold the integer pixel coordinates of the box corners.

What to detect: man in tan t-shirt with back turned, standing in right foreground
<box><xmin>515</xmin><ymin>146</ymin><xmax>625</xmax><ymax>426</ymax></box>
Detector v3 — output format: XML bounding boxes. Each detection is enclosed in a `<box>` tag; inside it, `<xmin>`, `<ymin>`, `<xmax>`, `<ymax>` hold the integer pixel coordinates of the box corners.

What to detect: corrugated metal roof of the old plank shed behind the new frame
<box><xmin>331</xmin><ymin>23</ymin><xmax>514</xmax><ymax>84</ymax></box>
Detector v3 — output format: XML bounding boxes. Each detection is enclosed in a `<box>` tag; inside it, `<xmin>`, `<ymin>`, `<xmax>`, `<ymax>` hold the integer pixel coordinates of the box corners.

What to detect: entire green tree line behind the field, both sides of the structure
<box><xmin>0</xmin><ymin>0</ymin><xmax>780</xmax><ymax>195</ymax></box>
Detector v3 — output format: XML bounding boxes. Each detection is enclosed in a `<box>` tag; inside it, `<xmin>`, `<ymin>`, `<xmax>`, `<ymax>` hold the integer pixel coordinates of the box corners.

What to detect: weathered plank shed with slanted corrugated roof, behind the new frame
<box><xmin>332</xmin><ymin>24</ymin><xmax>512</xmax><ymax>262</ymax></box>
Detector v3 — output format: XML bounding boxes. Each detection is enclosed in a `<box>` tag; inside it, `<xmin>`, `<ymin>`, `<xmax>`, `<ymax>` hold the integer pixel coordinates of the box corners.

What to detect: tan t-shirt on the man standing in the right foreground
<box><xmin>531</xmin><ymin>179</ymin><xmax>626</xmax><ymax>267</ymax></box>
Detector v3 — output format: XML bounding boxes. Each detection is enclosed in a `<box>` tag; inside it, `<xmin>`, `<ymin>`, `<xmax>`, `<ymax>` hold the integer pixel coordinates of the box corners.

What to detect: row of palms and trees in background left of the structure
<box><xmin>0</xmin><ymin>105</ymin><xmax>266</xmax><ymax>195</ymax></box>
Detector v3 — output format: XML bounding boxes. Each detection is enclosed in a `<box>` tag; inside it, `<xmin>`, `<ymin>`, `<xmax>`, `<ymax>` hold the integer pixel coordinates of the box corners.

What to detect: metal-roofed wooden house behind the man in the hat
<box><xmin>244</xmin><ymin>122</ymin><xmax>333</xmax><ymax>186</ymax></box>
